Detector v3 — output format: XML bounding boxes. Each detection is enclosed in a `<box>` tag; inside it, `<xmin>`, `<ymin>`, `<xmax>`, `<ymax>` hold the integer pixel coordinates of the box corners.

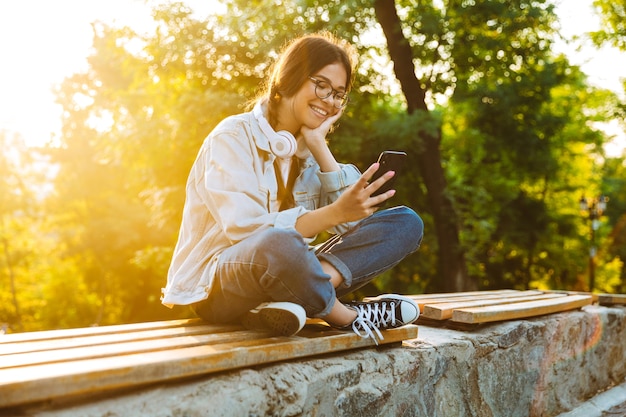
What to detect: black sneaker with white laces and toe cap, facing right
<box><xmin>340</xmin><ymin>294</ymin><xmax>420</xmax><ymax>344</ymax></box>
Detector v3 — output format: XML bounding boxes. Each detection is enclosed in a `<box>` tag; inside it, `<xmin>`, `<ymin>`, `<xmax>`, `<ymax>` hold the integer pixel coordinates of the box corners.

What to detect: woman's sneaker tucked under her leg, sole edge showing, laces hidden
<box><xmin>242</xmin><ymin>302</ymin><xmax>306</xmax><ymax>336</ymax></box>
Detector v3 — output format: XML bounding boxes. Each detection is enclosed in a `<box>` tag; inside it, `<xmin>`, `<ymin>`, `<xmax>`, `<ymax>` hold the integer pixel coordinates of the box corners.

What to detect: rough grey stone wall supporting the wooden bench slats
<box><xmin>23</xmin><ymin>306</ymin><xmax>626</xmax><ymax>417</ymax></box>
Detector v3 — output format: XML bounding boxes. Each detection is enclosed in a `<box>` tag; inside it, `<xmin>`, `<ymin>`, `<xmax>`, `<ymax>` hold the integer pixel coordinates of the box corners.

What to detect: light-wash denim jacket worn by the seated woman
<box><xmin>161</xmin><ymin>112</ymin><xmax>360</xmax><ymax>307</ymax></box>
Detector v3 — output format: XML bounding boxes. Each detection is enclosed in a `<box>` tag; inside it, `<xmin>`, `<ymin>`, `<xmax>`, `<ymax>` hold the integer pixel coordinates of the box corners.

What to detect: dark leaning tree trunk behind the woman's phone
<box><xmin>374</xmin><ymin>0</ymin><xmax>478</xmax><ymax>292</ymax></box>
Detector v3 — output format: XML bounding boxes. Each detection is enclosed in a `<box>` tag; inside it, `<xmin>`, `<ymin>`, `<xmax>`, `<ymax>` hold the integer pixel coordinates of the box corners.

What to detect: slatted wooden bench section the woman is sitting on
<box><xmin>0</xmin><ymin>319</ymin><xmax>417</xmax><ymax>409</ymax></box>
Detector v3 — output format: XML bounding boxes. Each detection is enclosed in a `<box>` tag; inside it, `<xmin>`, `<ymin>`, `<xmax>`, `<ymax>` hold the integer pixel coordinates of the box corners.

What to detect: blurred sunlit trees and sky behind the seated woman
<box><xmin>0</xmin><ymin>0</ymin><xmax>626</xmax><ymax>332</ymax></box>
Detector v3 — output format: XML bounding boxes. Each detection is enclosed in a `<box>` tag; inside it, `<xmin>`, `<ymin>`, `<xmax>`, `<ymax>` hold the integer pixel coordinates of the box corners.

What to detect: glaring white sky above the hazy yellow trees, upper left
<box><xmin>0</xmin><ymin>0</ymin><xmax>215</xmax><ymax>145</ymax></box>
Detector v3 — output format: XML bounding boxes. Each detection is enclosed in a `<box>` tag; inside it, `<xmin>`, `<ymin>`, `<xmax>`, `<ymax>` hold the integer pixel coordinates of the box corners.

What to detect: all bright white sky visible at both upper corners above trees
<box><xmin>0</xmin><ymin>0</ymin><xmax>626</xmax><ymax>155</ymax></box>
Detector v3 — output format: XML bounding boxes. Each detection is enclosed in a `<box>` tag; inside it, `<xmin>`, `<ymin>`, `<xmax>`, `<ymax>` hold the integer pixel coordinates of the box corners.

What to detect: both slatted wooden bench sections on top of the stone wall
<box><xmin>0</xmin><ymin>290</ymin><xmax>626</xmax><ymax>409</ymax></box>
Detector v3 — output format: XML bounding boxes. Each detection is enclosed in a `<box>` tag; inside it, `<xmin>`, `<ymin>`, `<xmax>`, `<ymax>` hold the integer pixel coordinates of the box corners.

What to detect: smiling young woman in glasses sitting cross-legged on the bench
<box><xmin>162</xmin><ymin>33</ymin><xmax>423</xmax><ymax>340</ymax></box>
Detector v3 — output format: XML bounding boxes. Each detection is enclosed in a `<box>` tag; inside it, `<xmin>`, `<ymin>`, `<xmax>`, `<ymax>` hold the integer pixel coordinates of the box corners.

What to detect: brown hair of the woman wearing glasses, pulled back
<box><xmin>263</xmin><ymin>32</ymin><xmax>356</xmax><ymax>126</ymax></box>
